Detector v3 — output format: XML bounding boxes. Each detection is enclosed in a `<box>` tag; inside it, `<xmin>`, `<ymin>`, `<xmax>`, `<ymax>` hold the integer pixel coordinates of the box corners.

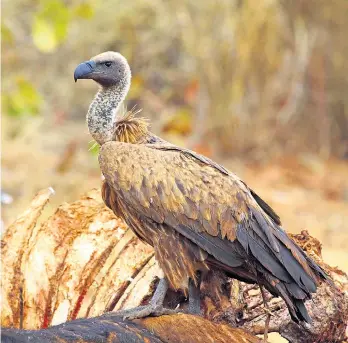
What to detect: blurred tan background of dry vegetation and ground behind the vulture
<box><xmin>1</xmin><ymin>0</ymin><xmax>348</xmax><ymax>334</ymax></box>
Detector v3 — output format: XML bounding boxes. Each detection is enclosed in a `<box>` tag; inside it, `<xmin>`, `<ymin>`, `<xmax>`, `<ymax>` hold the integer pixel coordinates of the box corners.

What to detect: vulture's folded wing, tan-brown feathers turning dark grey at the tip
<box><xmin>99</xmin><ymin>142</ymin><xmax>324</xmax><ymax>296</ymax></box>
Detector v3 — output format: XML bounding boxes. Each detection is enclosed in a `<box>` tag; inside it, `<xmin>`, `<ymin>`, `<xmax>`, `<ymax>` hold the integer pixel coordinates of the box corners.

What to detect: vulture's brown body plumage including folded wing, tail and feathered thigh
<box><xmin>99</xmin><ymin>120</ymin><xmax>325</xmax><ymax>321</ymax></box>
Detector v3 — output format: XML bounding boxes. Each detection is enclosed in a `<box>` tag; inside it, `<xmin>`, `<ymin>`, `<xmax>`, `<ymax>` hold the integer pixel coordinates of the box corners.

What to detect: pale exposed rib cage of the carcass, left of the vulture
<box><xmin>2</xmin><ymin>190</ymin><xmax>158</xmax><ymax>329</ymax></box>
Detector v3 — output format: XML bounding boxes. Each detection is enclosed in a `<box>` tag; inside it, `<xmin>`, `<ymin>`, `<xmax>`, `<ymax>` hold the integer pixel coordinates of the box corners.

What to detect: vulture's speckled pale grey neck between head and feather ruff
<box><xmin>87</xmin><ymin>80</ymin><xmax>130</xmax><ymax>145</ymax></box>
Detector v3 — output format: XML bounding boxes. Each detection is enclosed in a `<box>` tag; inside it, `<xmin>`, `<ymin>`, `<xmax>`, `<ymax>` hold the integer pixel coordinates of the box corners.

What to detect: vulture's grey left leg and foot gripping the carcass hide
<box><xmin>119</xmin><ymin>278</ymin><xmax>177</xmax><ymax>319</ymax></box>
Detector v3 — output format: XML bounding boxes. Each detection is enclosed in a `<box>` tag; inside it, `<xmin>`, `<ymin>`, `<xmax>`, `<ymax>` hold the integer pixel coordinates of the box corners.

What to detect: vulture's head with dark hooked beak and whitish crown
<box><xmin>74</xmin><ymin>51</ymin><xmax>131</xmax><ymax>87</ymax></box>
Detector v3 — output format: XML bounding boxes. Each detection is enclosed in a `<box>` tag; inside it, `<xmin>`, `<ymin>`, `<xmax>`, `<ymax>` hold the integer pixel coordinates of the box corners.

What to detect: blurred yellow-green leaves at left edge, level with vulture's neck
<box><xmin>2</xmin><ymin>77</ymin><xmax>42</xmax><ymax>117</ymax></box>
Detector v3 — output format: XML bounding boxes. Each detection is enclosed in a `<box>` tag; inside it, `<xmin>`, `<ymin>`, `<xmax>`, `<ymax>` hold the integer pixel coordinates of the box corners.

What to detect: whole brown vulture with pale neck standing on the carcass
<box><xmin>74</xmin><ymin>51</ymin><xmax>329</xmax><ymax>323</ymax></box>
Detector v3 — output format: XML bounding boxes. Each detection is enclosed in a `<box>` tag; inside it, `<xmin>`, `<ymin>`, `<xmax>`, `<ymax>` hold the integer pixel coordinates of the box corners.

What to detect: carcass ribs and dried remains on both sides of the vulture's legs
<box><xmin>1</xmin><ymin>190</ymin><xmax>348</xmax><ymax>343</ymax></box>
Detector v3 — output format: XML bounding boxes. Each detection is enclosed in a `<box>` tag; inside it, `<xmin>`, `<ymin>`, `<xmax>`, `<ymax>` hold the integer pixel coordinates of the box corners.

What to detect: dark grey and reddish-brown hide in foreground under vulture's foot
<box><xmin>1</xmin><ymin>313</ymin><xmax>261</xmax><ymax>343</ymax></box>
